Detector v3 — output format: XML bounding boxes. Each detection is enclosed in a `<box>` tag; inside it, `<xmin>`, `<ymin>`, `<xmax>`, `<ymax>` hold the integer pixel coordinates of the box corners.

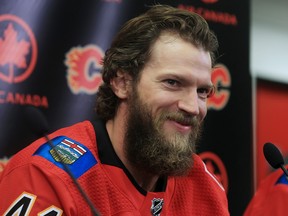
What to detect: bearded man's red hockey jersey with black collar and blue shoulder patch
<box><xmin>0</xmin><ymin>121</ymin><xmax>229</xmax><ymax>216</ymax></box>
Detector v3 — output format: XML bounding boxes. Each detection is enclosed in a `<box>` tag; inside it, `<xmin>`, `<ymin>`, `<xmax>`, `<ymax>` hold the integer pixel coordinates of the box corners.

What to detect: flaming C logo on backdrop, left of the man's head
<box><xmin>65</xmin><ymin>45</ymin><xmax>104</xmax><ymax>94</ymax></box>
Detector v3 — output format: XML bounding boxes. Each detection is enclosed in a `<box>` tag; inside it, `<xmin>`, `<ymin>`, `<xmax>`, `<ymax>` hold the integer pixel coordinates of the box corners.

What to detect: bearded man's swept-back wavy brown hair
<box><xmin>96</xmin><ymin>5</ymin><xmax>218</xmax><ymax>121</ymax></box>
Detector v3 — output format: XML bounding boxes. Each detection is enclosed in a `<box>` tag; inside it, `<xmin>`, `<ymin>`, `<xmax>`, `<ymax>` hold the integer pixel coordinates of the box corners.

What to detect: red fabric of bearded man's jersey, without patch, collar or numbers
<box><xmin>0</xmin><ymin>121</ymin><xmax>229</xmax><ymax>216</ymax></box>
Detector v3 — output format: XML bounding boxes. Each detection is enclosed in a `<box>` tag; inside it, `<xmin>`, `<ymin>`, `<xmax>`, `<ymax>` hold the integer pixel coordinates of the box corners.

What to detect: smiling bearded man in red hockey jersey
<box><xmin>0</xmin><ymin>5</ymin><xmax>229</xmax><ymax>216</ymax></box>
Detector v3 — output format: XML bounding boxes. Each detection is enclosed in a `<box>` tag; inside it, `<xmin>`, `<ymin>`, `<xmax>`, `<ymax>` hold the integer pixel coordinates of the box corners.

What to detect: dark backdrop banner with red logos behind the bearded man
<box><xmin>0</xmin><ymin>0</ymin><xmax>253</xmax><ymax>216</ymax></box>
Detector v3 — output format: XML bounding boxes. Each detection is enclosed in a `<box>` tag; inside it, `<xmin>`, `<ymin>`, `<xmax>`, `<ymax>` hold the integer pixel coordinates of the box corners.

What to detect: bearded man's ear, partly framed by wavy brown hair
<box><xmin>110</xmin><ymin>70</ymin><xmax>132</xmax><ymax>99</ymax></box>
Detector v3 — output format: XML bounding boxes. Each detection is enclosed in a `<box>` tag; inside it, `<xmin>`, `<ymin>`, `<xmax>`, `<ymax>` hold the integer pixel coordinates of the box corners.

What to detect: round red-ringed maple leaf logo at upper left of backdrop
<box><xmin>0</xmin><ymin>14</ymin><xmax>37</xmax><ymax>83</ymax></box>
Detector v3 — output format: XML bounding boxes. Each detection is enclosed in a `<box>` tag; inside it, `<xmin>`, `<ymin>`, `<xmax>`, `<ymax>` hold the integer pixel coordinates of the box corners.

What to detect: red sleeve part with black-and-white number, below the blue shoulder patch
<box><xmin>0</xmin><ymin>156</ymin><xmax>77</xmax><ymax>216</ymax></box>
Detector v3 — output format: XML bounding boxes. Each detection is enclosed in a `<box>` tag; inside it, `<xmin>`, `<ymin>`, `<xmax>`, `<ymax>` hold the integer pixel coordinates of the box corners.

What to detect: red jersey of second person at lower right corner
<box><xmin>244</xmin><ymin>169</ymin><xmax>288</xmax><ymax>216</ymax></box>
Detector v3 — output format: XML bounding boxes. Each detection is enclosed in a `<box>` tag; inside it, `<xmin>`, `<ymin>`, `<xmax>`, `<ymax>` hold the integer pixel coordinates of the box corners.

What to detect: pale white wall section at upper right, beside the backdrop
<box><xmin>250</xmin><ymin>0</ymin><xmax>288</xmax><ymax>84</ymax></box>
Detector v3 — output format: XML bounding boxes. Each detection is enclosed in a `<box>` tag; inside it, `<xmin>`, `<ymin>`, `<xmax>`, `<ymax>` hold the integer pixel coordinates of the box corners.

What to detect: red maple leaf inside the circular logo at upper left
<box><xmin>0</xmin><ymin>23</ymin><xmax>30</xmax><ymax>83</ymax></box>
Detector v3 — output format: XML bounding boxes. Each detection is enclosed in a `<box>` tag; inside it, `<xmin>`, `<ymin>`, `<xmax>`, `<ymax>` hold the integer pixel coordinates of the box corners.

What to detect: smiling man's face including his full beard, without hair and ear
<box><xmin>125</xmin><ymin>34</ymin><xmax>212</xmax><ymax>175</ymax></box>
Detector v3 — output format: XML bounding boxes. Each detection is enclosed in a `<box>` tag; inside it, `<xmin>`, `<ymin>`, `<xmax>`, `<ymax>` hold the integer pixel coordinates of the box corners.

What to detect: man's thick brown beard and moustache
<box><xmin>124</xmin><ymin>90</ymin><xmax>202</xmax><ymax>176</ymax></box>
